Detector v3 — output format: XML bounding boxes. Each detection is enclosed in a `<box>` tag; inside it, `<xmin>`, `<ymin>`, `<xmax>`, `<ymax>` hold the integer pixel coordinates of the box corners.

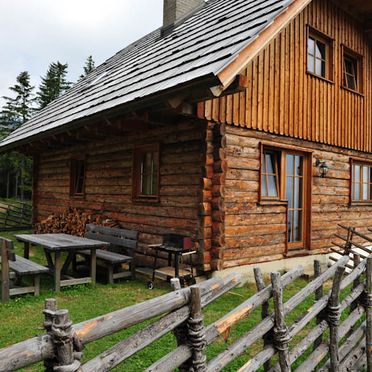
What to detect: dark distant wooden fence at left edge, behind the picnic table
<box><xmin>0</xmin><ymin>201</ymin><xmax>32</xmax><ymax>231</ymax></box>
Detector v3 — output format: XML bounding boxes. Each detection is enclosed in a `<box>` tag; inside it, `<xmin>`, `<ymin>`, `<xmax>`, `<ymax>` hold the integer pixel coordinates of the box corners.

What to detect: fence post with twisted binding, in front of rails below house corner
<box><xmin>187</xmin><ymin>286</ymin><xmax>207</xmax><ymax>372</ymax></box>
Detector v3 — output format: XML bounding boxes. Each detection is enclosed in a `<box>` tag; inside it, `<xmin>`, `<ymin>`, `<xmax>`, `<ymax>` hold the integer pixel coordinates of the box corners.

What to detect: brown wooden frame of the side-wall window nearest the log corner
<box><xmin>132</xmin><ymin>143</ymin><xmax>160</xmax><ymax>203</ymax></box>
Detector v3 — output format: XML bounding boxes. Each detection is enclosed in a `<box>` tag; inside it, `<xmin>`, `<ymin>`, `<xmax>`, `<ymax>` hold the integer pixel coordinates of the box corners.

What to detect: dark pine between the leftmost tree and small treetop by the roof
<box><xmin>37</xmin><ymin>62</ymin><xmax>71</xmax><ymax>109</ymax></box>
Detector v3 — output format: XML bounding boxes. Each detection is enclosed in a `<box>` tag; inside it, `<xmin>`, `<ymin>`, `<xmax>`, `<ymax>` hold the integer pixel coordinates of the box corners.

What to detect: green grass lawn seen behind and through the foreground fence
<box><xmin>0</xmin><ymin>233</ymin><xmax>338</xmax><ymax>371</ymax></box>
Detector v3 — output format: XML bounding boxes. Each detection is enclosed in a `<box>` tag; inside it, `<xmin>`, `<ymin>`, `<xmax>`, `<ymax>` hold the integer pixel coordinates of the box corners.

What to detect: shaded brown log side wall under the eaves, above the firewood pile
<box><xmin>34</xmin><ymin>122</ymin><xmax>211</xmax><ymax>265</ymax></box>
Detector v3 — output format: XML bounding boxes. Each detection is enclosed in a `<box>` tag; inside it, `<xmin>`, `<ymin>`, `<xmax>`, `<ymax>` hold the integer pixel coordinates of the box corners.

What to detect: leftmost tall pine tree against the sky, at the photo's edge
<box><xmin>1</xmin><ymin>71</ymin><xmax>35</xmax><ymax>130</ymax></box>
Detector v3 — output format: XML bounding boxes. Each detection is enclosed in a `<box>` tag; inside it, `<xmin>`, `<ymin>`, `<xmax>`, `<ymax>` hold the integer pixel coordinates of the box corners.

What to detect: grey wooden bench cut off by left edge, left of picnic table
<box><xmin>0</xmin><ymin>238</ymin><xmax>49</xmax><ymax>302</ymax></box>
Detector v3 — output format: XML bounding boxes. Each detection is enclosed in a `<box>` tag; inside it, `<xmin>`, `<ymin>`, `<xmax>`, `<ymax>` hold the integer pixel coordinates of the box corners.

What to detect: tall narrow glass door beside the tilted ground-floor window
<box><xmin>285</xmin><ymin>153</ymin><xmax>305</xmax><ymax>250</ymax></box>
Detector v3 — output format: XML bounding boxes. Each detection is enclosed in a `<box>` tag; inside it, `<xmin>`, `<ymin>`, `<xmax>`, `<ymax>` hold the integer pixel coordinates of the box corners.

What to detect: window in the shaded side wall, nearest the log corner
<box><xmin>133</xmin><ymin>145</ymin><xmax>159</xmax><ymax>201</ymax></box>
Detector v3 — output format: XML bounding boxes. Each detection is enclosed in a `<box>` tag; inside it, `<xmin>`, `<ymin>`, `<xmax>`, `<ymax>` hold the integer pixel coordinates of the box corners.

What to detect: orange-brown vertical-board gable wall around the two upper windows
<box><xmin>198</xmin><ymin>0</ymin><xmax>372</xmax><ymax>152</ymax></box>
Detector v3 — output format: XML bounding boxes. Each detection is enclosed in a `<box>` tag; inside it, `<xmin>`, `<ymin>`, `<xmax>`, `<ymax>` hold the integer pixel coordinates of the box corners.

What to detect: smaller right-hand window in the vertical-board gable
<box><xmin>342</xmin><ymin>47</ymin><xmax>363</xmax><ymax>93</ymax></box>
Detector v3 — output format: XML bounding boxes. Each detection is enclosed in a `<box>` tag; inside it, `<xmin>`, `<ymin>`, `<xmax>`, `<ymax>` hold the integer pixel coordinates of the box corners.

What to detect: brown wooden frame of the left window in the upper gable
<box><xmin>305</xmin><ymin>25</ymin><xmax>334</xmax><ymax>84</ymax></box>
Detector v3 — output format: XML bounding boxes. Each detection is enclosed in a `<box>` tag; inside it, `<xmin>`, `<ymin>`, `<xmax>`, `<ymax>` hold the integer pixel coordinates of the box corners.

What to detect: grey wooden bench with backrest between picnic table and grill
<box><xmin>77</xmin><ymin>224</ymin><xmax>138</xmax><ymax>284</ymax></box>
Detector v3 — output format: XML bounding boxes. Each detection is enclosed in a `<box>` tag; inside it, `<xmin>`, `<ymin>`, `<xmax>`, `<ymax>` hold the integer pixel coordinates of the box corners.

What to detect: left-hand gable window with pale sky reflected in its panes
<box><xmin>307</xmin><ymin>28</ymin><xmax>332</xmax><ymax>80</ymax></box>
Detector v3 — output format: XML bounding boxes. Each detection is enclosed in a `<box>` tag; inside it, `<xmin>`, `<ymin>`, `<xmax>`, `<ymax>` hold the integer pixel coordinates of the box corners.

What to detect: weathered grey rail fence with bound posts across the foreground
<box><xmin>0</xmin><ymin>256</ymin><xmax>372</xmax><ymax>372</ymax></box>
